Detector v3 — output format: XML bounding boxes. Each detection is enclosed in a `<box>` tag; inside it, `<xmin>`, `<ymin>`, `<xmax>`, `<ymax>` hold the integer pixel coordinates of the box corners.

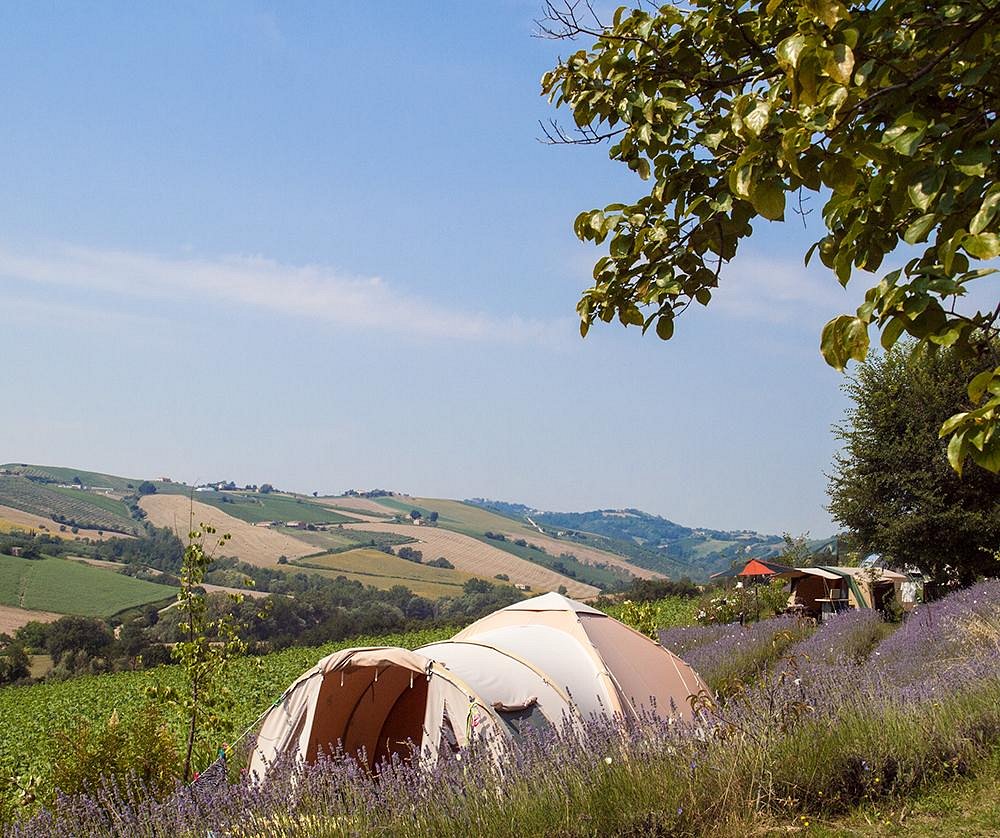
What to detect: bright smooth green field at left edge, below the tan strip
<box><xmin>0</xmin><ymin>555</ymin><xmax>177</xmax><ymax>617</ymax></box>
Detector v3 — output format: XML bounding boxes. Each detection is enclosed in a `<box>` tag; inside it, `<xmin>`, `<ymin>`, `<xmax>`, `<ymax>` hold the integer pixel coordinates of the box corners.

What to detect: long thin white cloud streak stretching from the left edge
<box><xmin>0</xmin><ymin>246</ymin><xmax>564</xmax><ymax>342</ymax></box>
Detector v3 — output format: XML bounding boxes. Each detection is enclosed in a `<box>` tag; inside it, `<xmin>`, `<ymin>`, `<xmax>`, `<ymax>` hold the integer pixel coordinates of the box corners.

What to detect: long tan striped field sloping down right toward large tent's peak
<box><xmin>344</xmin><ymin>523</ymin><xmax>599</xmax><ymax>599</ymax></box>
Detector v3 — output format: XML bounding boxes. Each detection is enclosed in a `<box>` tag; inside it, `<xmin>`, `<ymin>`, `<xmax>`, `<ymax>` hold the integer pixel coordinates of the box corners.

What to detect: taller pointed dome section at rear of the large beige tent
<box><xmin>454</xmin><ymin>593</ymin><xmax>708</xmax><ymax>718</ymax></box>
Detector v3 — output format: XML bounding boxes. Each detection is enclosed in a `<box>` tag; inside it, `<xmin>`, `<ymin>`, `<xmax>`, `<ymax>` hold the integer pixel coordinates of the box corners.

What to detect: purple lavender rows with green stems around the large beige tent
<box><xmin>5</xmin><ymin>581</ymin><xmax>1000</xmax><ymax>838</ymax></box>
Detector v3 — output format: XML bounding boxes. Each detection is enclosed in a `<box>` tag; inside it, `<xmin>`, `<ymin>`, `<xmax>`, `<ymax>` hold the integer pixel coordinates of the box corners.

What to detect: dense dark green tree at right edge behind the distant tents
<box><xmin>829</xmin><ymin>342</ymin><xmax>1000</xmax><ymax>582</ymax></box>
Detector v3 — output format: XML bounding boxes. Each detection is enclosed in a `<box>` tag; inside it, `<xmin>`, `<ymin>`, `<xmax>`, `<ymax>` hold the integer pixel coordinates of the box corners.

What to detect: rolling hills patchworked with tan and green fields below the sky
<box><xmin>0</xmin><ymin>463</ymin><xmax>804</xmax><ymax>612</ymax></box>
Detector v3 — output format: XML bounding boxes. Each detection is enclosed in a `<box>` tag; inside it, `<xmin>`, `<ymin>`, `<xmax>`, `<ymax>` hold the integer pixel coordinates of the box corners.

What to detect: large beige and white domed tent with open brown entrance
<box><xmin>250</xmin><ymin>594</ymin><xmax>707</xmax><ymax>776</ymax></box>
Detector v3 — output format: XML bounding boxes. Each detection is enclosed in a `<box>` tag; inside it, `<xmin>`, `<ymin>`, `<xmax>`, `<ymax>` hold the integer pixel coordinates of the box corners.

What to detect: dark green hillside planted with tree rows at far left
<box><xmin>0</xmin><ymin>474</ymin><xmax>138</xmax><ymax>535</ymax></box>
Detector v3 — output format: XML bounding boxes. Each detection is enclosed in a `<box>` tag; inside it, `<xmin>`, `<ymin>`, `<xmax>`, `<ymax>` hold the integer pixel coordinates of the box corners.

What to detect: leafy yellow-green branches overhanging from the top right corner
<box><xmin>541</xmin><ymin>0</ymin><xmax>1000</xmax><ymax>471</ymax></box>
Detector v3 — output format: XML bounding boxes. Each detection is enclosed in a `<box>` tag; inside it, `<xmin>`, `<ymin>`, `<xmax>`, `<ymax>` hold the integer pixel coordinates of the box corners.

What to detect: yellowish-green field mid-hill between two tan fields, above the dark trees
<box><xmin>294</xmin><ymin>548</ymin><xmax>472</xmax><ymax>599</ymax></box>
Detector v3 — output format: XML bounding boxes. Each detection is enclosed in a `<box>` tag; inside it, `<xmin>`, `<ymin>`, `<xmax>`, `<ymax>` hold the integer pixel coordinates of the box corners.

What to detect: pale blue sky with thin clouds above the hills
<box><xmin>0</xmin><ymin>0</ymin><xmax>884</xmax><ymax>536</ymax></box>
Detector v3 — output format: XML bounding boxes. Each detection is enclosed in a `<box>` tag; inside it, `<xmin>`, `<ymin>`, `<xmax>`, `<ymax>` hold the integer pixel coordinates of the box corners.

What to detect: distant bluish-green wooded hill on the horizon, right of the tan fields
<box><xmin>468</xmin><ymin>498</ymin><xmax>783</xmax><ymax>581</ymax></box>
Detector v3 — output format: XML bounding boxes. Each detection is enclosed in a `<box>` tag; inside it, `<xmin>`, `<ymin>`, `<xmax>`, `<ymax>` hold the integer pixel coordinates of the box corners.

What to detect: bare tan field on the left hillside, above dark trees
<box><xmin>139</xmin><ymin>494</ymin><xmax>316</xmax><ymax>567</ymax></box>
